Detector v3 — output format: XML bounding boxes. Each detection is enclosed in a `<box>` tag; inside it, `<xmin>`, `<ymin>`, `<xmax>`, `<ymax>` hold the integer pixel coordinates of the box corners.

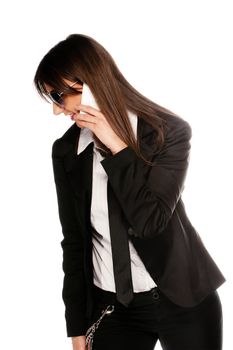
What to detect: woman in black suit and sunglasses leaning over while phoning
<box><xmin>34</xmin><ymin>34</ymin><xmax>225</xmax><ymax>350</ymax></box>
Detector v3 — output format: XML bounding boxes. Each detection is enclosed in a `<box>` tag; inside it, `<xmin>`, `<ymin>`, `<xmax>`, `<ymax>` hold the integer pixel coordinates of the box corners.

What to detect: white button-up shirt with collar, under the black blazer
<box><xmin>77</xmin><ymin>112</ymin><xmax>156</xmax><ymax>292</ymax></box>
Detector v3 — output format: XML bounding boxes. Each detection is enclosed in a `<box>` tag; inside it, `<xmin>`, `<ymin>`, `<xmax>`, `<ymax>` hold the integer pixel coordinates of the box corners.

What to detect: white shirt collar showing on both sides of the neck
<box><xmin>77</xmin><ymin>111</ymin><xmax>138</xmax><ymax>154</ymax></box>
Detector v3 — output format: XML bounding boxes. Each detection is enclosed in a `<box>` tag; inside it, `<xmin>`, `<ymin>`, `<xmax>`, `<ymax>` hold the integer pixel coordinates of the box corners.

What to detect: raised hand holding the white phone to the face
<box><xmin>74</xmin><ymin>105</ymin><xmax>127</xmax><ymax>154</ymax></box>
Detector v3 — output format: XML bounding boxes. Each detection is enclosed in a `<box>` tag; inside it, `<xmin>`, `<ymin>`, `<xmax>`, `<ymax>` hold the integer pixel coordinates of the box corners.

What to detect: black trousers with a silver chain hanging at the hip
<box><xmin>90</xmin><ymin>287</ymin><xmax>223</xmax><ymax>350</ymax></box>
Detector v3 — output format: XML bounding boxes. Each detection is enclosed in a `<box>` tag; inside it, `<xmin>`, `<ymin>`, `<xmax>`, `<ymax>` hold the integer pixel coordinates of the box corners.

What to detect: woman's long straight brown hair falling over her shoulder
<box><xmin>34</xmin><ymin>34</ymin><xmax>176</xmax><ymax>165</ymax></box>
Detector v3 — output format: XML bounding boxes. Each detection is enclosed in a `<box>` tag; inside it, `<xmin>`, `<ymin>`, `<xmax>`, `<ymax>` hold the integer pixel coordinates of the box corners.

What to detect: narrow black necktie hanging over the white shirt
<box><xmin>107</xmin><ymin>180</ymin><xmax>133</xmax><ymax>306</ymax></box>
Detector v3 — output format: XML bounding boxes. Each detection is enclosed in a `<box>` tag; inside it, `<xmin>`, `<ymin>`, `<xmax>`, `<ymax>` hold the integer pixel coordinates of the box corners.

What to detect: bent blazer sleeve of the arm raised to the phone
<box><xmin>101</xmin><ymin>118</ymin><xmax>192</xmax><ymax>239</ymax></box>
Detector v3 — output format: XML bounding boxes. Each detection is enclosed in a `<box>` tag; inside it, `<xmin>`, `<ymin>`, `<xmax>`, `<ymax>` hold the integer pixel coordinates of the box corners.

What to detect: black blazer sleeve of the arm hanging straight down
<box><xmin>52</xmin><ymin>139</ymin><xmax>86</xmax><ymax>337</ymax></box>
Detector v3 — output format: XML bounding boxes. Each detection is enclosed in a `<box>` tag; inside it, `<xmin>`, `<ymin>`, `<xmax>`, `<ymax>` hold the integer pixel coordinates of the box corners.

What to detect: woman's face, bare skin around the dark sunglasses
<box><xmin>45</xmin><ymin>79</ymin><xmax>83</xmax><ymax>128</ymax></box>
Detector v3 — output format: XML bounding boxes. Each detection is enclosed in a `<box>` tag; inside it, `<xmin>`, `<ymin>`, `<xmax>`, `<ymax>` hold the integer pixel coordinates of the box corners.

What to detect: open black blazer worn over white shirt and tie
<box><xmin>52</xmin><ymin>117</ymin><xmax>225</xmax><ymax>336</ymax></box>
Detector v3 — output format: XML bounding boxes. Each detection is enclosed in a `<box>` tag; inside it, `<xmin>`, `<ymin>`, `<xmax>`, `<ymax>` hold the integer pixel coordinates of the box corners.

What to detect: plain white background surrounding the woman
<box><xmin>0</xmin><ymin>0</ymin><xmax>233</xmax><ymax>350</ymax></box>
